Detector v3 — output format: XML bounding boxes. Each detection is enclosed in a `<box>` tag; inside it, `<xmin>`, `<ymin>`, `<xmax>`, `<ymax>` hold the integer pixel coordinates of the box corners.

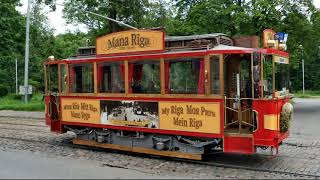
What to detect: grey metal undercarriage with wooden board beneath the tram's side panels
<box><xmin>66</xmin><ymin>126</ymin><xmax>223</xmax><ymax>160</ymax></box>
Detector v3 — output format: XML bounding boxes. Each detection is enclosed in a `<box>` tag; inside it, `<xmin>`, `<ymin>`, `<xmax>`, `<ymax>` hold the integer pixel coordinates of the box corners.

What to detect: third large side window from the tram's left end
<box><xmin>129</xmin><ymin>60</ymin><xmax>160</xmax><ymax>94</ymax></box>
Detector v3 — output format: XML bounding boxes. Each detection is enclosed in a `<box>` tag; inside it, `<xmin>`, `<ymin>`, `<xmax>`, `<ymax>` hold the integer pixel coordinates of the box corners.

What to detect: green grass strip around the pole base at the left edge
<box><xmin>0</xmin><ymin>94</ymin><xmax>44</xmax><ymax>111</ymax></box>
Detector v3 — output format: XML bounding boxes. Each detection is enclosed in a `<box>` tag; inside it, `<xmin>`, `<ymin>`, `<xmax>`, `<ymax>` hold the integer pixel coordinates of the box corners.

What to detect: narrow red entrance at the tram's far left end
<box><xmin>46</xmin><ymin>64</ymin><xmax>60</xmax><ymax>131</ymax></box>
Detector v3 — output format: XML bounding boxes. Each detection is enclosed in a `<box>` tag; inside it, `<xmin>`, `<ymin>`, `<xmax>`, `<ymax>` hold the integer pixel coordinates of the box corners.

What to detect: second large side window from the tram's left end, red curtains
<box><xmin>98</xmin><ymin>62</ymin><xmax>124</xmax><ymax>93</ymax></box>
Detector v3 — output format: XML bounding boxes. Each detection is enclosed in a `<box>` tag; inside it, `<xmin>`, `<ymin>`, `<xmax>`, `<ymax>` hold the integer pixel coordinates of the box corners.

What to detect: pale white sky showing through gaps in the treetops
<box><xmin>17</xmin><ymin>0</ymin><xmax>320</xmax><ymax>35</ymax></box>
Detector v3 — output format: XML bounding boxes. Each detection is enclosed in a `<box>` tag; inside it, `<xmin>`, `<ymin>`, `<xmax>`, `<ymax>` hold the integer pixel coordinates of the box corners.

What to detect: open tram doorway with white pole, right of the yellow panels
<box><xmin>224</xmin><ymin>54</ymin><xmax>253</xmax><ymax>133</ymax></box>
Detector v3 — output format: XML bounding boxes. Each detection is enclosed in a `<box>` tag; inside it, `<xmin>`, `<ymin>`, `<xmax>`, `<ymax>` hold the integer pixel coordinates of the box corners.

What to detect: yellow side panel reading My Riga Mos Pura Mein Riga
<box><xmin>159</xmin><ymin>102</ymin><xmax>221</xmax><ymax>133</ymax></box>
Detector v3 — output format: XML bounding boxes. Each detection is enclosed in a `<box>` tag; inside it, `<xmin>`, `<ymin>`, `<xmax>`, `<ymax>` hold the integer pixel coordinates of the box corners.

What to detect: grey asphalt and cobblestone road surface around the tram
<box><xmin>0</xmin><ymin>98</ymin><xmax>320</xmax><ymax>179</ymax></box>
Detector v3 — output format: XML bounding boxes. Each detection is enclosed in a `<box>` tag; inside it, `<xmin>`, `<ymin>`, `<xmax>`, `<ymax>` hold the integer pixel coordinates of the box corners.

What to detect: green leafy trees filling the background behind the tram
<box><xmin>0</xmin><ymin>0</ymin><xmax>320</xmax><ymax>107</ymax></box>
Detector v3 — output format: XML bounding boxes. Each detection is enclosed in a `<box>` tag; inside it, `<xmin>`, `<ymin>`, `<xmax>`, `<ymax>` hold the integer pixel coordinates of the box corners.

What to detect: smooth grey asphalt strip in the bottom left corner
<box><xmin>0</xmin><ymin>151</ymin><xmax>178</xmax><ymax>179</ymax></box>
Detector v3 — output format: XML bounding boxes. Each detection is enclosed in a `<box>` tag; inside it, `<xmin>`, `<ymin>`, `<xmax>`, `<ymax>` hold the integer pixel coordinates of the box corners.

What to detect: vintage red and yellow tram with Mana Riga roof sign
<box><xmin>44</xmin><ymin>30</ymin><xmax>292</xmax><ymax>160</ymax></box>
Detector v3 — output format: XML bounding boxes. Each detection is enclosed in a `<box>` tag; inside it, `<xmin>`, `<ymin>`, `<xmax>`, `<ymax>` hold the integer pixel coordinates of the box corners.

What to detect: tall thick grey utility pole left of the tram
<box><xmin>24</xmin><ymin>0</ymin><xmax>31</xmax><ymax>103</ymax></box>
